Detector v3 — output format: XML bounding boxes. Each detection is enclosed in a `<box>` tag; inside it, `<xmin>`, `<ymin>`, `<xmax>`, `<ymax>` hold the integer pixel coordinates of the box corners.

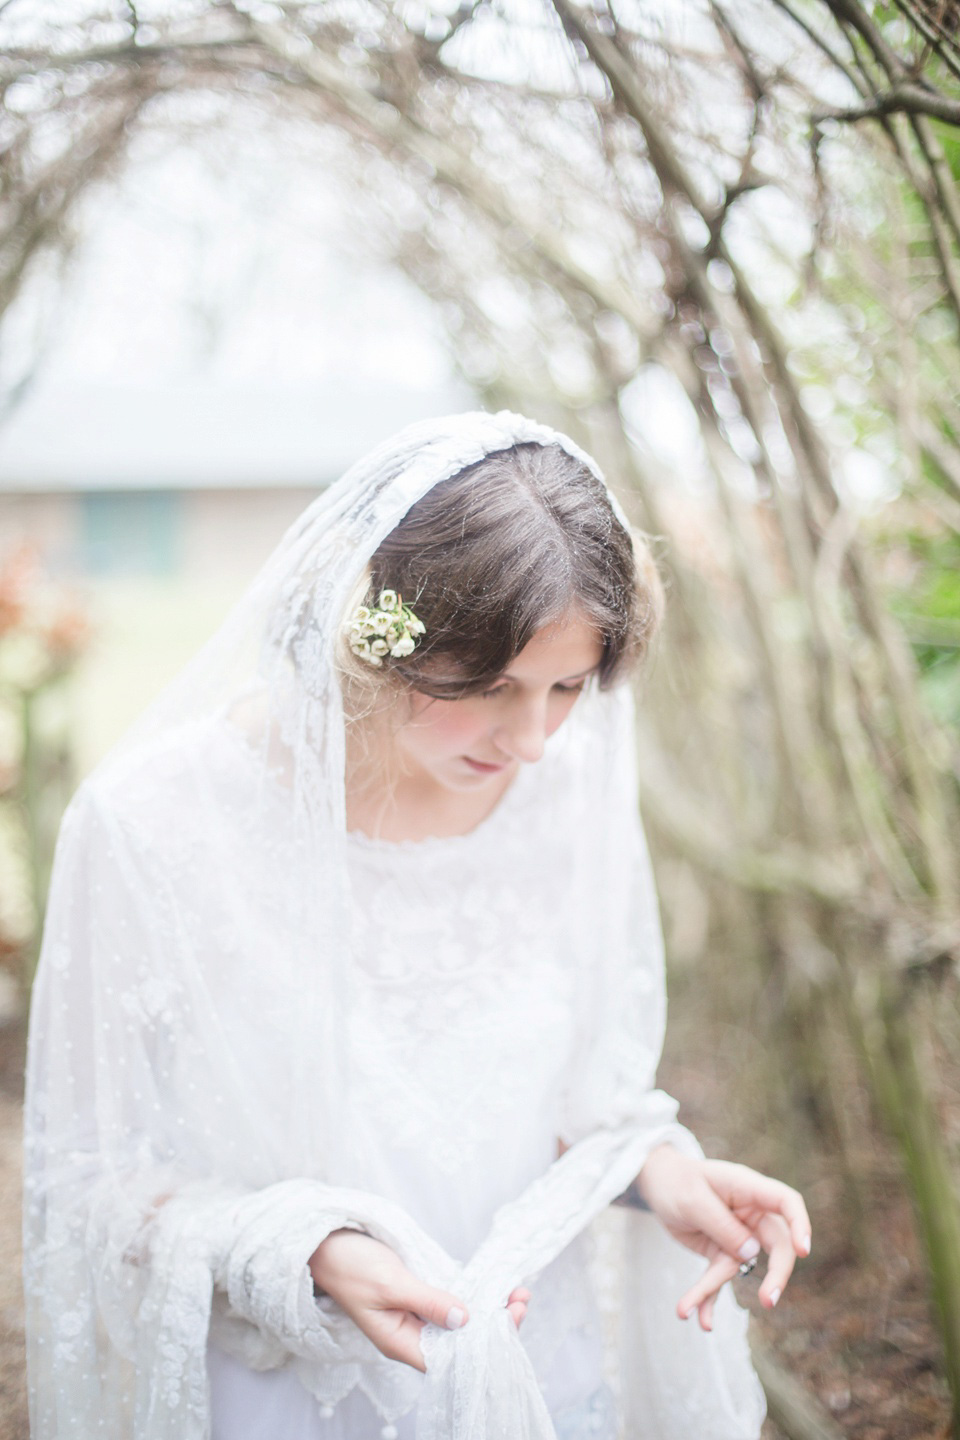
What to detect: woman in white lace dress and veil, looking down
<box><xmin>24</xmin><ymin>412</ymin><xmax>810</xmax><ymax>1440</ymax></box>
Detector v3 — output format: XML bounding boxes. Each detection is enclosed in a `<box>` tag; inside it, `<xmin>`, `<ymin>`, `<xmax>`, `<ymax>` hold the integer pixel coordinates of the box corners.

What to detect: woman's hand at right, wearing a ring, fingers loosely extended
<box><xmin>636</xmin><ymin>1143</ymin><xmax>810</xmax><ymax>1331</ymax></box>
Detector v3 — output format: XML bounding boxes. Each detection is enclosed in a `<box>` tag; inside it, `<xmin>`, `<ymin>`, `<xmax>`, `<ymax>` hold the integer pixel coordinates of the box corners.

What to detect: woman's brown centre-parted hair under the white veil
<box><xmin>344</xmin><ymin>444</ymin><xmax>662</xmax><ymax>700</ymax></box>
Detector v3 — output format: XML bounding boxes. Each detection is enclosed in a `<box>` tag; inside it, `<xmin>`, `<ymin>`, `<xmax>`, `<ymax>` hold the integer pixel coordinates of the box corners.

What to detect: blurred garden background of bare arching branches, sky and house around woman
<box><xmin>0</xmin><ymin>0</ymin><xmax>960</xmax><ymax>1440</ymax></box>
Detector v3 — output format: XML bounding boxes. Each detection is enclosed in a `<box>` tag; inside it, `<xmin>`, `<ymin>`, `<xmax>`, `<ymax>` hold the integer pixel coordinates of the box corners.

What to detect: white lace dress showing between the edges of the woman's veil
<box><xmin>209</xmin><ymin>748</ymin><xmax>615</xmax><ymax>1440</ymax></box>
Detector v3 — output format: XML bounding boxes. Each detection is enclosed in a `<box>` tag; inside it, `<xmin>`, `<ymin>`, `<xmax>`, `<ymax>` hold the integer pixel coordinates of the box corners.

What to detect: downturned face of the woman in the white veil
<box><xmin>396</xmin><ymin>612</ymin><xmax>603</xmax><ymax>791</ymax></box>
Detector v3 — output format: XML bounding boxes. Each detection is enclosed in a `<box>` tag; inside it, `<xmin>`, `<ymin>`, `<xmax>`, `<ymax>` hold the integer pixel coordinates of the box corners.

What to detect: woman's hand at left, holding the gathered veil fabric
<box><xmin>309</xmin><ymin>1230</ymin><xmax>530</xmax><ymax>1371</ymax></box>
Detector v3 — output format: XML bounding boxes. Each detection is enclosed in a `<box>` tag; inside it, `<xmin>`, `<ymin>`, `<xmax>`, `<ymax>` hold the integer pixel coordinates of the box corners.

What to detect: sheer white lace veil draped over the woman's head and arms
<box><xmin>24</xmin><ymin>412</ymin><xmax>763</xmax><ymax>1440</ymax></box>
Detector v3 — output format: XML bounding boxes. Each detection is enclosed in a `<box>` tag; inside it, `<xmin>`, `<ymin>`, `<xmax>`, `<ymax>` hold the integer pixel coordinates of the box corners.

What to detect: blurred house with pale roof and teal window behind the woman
<box><xmin>0</xmin><ymin>382</ymin><xmax>475</xmax><ymax>585</ymax></box>
